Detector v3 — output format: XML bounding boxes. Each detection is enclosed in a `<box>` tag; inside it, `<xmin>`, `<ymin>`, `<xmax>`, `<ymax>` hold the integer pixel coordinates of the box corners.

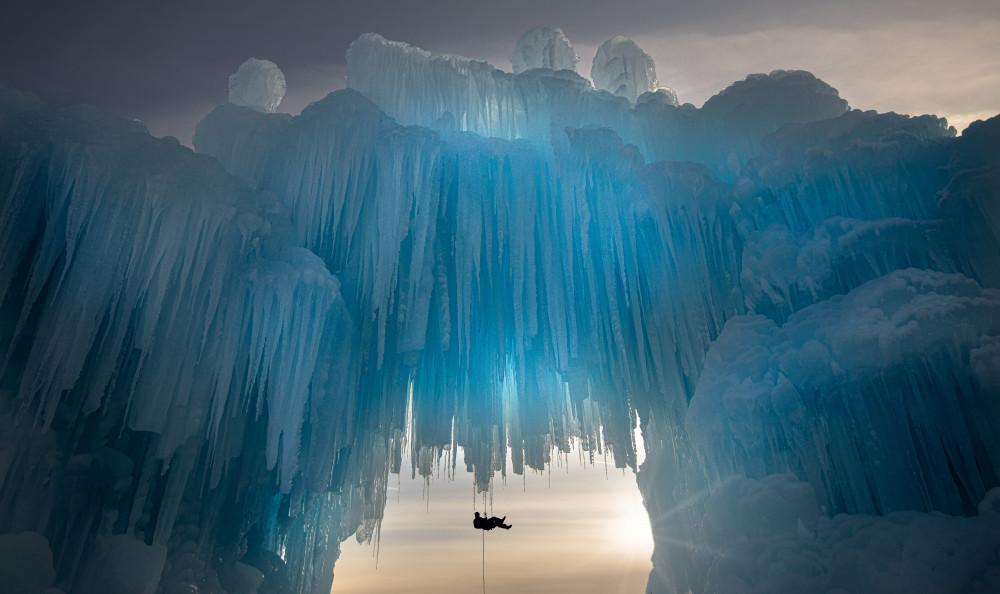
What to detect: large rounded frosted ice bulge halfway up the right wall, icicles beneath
<box><xmin>687</xmin><ymin>269</ymin><xmax>1000</xmax><ymax>513</ymax></box>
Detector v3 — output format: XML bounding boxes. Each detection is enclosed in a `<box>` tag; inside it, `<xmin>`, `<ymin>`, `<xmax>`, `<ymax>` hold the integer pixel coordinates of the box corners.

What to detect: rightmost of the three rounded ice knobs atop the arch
<box><xmin>590</xmin><ymin>35</ymin><xmax>657</xmax><ymax>103</ymax></box>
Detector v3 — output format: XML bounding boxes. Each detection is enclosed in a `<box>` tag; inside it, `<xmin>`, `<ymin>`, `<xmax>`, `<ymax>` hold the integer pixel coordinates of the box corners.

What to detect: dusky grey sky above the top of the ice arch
<box><xmin>0</xmin><ymin>0</ymin><xmax>1000</xmax><ymax>143</ymax></box>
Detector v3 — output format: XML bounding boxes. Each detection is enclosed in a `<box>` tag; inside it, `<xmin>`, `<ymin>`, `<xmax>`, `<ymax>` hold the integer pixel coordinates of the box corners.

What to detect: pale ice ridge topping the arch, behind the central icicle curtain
<box><xmin>344</xmin><ymin>33</ymin><xmax>848</xmax><ymax>182</ymax></box>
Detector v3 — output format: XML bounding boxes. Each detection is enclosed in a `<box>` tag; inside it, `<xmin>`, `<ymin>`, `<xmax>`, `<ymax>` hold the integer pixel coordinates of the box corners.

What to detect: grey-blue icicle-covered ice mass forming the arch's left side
<box><xmin>0</xmin><ymin>89</ymin><xmax>366</xmax><ymax>589</ymax></box>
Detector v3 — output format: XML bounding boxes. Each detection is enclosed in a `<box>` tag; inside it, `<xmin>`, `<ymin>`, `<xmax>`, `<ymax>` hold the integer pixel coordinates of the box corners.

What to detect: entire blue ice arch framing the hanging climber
<box><xmin>0</xmin><ymin>34</ymin><xmax>1000</xmax><ymax>594</ymax></box>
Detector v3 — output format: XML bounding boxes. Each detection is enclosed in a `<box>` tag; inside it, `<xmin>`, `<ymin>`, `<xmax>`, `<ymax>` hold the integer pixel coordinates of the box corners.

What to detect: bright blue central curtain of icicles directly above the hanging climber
<box><xmin>195</xmin><ymin>91</ymin><xmax>752</xmax><ymax>488</ymax></box>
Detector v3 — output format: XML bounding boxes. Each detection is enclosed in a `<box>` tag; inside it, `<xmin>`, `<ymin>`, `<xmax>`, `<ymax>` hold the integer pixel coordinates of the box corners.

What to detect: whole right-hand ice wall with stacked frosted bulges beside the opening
<box><xmin>639</xmin><ymin>112</ymin><xmax>1000</xmax><ymax>592</ymax></box>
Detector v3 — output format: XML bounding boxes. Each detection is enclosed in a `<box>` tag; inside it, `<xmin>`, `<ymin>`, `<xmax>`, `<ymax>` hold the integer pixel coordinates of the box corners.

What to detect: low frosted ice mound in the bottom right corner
<box><xmin>702</xmin><ymin>473</ymin><xmax>1000</xmax><ymax>594</ymax></box>
